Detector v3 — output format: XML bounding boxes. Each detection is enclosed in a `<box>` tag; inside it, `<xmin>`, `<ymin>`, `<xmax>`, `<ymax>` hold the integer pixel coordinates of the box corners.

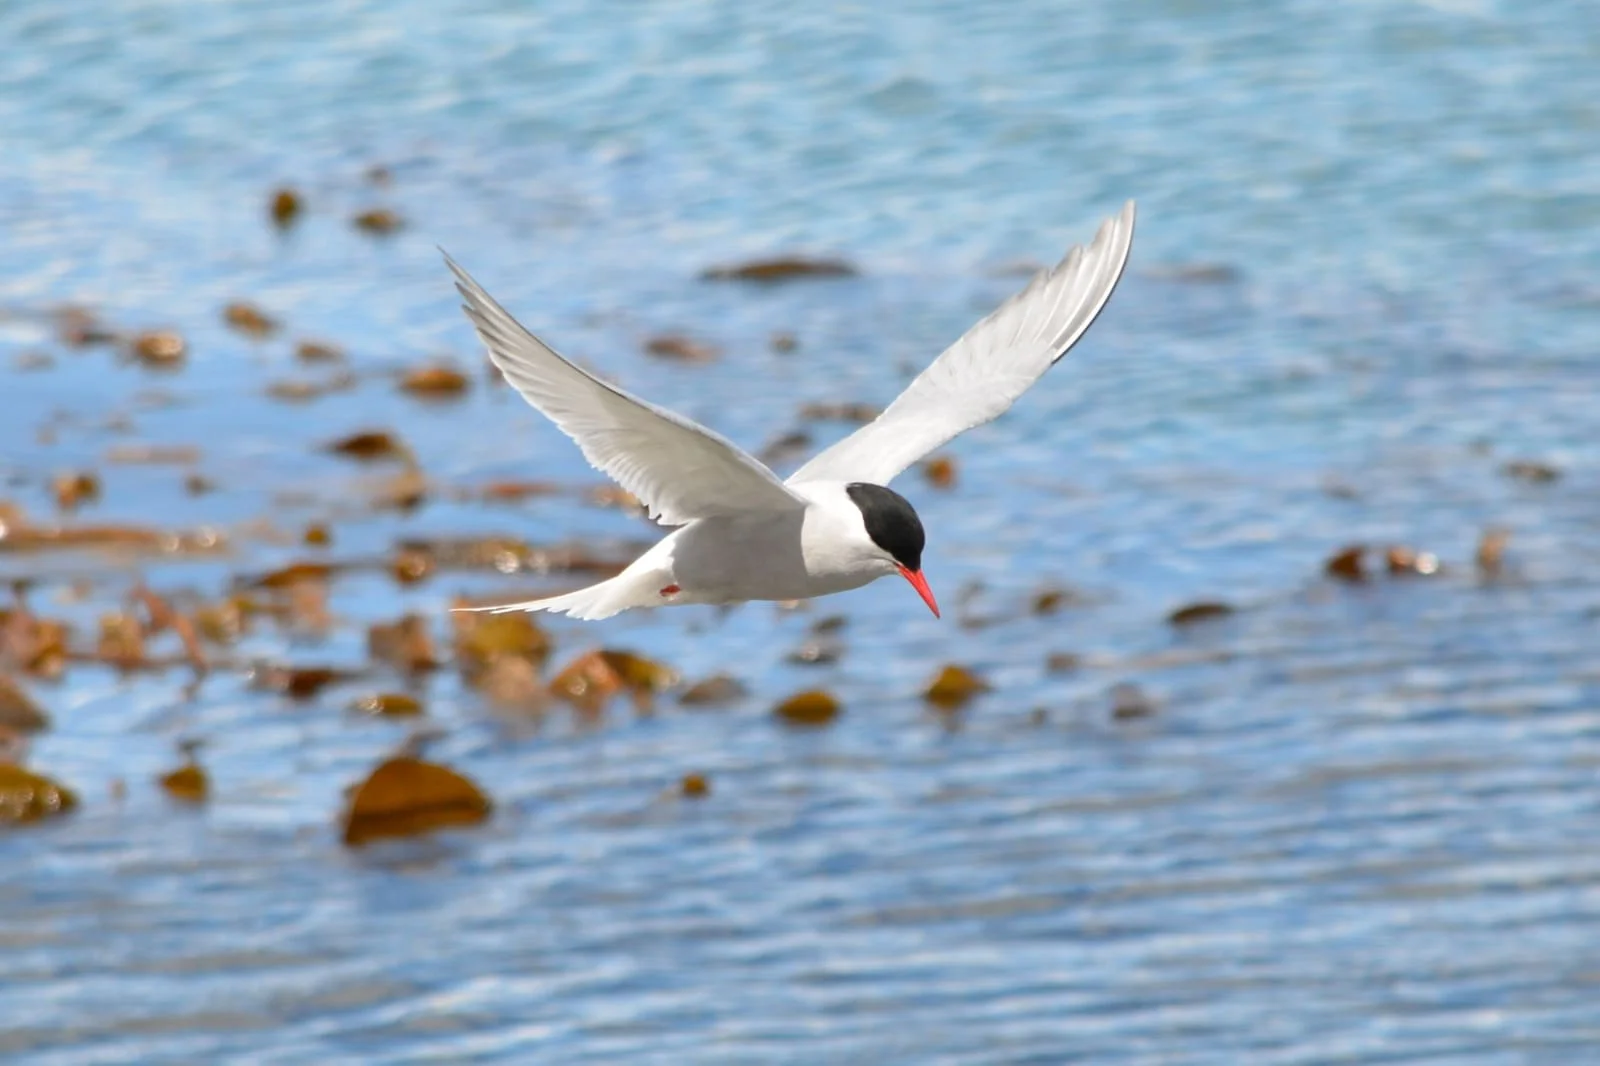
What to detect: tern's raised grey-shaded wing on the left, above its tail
<box><xmin>445</xmin><ymin>254</ymin><xmax>805</xmax><ymax>525</ymax></box>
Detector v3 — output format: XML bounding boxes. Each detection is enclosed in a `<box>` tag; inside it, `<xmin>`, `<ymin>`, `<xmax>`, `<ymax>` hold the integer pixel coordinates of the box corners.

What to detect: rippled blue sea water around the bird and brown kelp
<box><xmin>0</xmin><ymin>0</ymin><xmax>1600</xmax><ymax>1063</ymax></box>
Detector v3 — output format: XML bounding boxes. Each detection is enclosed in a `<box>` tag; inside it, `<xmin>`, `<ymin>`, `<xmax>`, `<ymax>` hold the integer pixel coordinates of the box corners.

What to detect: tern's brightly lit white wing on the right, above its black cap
<box><xmin>789</xmin><ymin>200</ymin><xmax>1134</xmax><ymax>485</ymax></box>
